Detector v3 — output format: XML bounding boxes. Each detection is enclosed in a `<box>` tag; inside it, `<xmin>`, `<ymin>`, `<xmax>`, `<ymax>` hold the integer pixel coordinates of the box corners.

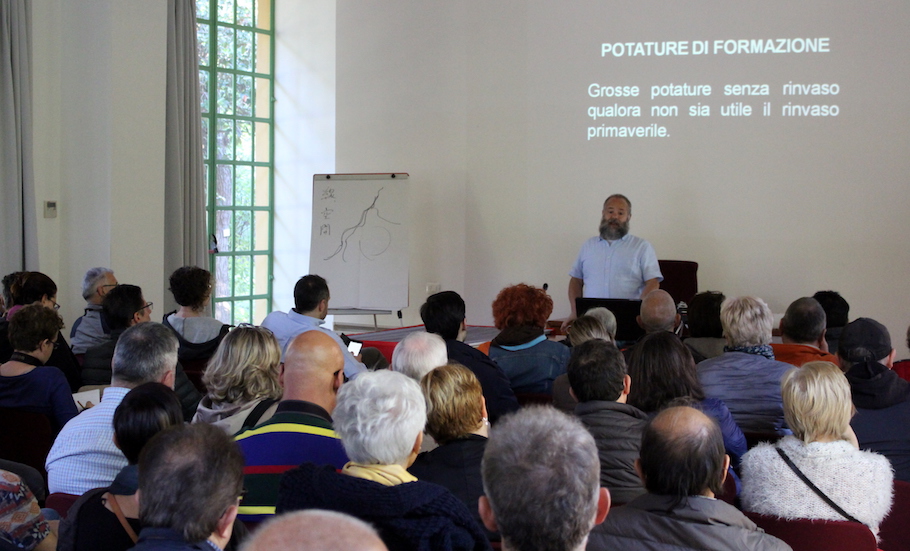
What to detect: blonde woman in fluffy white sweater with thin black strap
<box><xmin>742</xmin><ymin>362</ymin><xmax>893</xmax><ymax>534</ymax></box>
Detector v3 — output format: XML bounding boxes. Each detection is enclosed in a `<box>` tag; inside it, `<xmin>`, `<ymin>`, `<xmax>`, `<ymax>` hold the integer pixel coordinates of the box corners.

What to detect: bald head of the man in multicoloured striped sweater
<box><xmin>281</xmin><ymin>330</ymin><xmax>344</xmax><ymax>413</ymax></box>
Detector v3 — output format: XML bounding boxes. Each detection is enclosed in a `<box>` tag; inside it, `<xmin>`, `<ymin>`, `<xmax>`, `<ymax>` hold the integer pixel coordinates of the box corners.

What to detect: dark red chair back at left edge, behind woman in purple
<box><xmin>0</xmin><ymin>408</ymin><xmax>54</xmax><ymax>481</ymax></box>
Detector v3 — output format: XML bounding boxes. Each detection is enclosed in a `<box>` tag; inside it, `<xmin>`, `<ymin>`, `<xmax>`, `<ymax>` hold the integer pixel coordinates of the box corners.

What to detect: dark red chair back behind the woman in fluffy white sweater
<box><xmin>745</xmin><ymin>513</ymin><xmax>878</xmax><ymax>551</ymax></box>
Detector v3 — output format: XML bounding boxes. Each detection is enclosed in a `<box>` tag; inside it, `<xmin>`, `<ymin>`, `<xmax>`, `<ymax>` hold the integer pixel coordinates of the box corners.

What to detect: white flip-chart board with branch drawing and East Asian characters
<box><xmin>310</xmin><ymin>173</ymin><xmax>409</xmax><ymax>310</ymax></box>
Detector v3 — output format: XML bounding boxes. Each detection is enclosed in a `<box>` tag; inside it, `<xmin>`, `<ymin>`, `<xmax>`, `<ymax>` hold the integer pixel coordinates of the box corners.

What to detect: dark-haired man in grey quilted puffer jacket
<box><xmin>568</xmin><ymin>340</ymin><xmax>648</xmax><ymax>503</ymax></box>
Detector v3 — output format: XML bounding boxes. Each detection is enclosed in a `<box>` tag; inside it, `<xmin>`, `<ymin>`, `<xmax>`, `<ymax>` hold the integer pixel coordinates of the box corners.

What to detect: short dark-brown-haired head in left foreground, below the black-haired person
<box><xmin>139</xmin><ymin>423</ymin><xmax>243</xmax><ymax>547</ymax></box>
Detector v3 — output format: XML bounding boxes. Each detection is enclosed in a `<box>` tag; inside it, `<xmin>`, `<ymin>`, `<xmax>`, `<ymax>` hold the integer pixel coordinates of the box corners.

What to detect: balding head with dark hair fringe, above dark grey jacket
<box><xmin>636</xmin><ymin>406</ymin><xmax>730</xmax><ymax>500</ymax></box>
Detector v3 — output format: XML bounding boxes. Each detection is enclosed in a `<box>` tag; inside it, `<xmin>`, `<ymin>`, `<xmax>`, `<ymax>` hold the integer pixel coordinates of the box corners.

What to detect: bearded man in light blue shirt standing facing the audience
<box><xmin>569</xmin><ymin>193</ymin><xmax>663</xmax><ymax>319</ymax></box>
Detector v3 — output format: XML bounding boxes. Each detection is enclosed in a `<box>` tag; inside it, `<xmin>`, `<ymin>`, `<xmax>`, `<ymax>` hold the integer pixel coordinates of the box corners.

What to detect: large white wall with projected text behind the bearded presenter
<box><xmin>336</xmin><ymin>0</ymin><xmax>910</xmax><ymax>356</ymax></box>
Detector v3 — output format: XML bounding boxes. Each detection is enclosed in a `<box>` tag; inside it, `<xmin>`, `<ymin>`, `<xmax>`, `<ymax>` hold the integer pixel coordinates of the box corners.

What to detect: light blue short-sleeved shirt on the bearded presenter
<box><xmin>569</xmin><ymin>234</ymin><xmax>664</xmax><ymax>299</ymax></box>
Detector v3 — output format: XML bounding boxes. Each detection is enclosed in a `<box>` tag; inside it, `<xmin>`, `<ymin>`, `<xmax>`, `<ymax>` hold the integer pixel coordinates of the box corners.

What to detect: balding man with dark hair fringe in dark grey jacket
<box><xmin>588</xmin><ymin>407</ymin><xmax>790</xmax><ymax>551</ymax></box>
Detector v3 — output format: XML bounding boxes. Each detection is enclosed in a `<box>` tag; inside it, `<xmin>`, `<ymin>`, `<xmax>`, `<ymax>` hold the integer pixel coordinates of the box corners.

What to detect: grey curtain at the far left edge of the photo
<box><xmin>0</xmin><ymin>0</ymin><xmax>38</xmax><ymax>276</ymax></box>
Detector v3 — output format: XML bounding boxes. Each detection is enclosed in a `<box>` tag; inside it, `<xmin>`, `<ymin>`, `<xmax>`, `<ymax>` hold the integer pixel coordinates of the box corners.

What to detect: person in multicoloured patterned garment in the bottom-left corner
<box><xmin>0</xmin><ymin>470</ymin><xmax>57</xmax><ymax>551</ymax></box>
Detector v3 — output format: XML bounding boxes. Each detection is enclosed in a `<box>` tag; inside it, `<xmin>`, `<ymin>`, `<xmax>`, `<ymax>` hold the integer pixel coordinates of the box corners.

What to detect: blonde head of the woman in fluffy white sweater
<box><xmin>780</xmin><ymin>362</ymin><xmax>856</xmax><ymax>444</ymax></box>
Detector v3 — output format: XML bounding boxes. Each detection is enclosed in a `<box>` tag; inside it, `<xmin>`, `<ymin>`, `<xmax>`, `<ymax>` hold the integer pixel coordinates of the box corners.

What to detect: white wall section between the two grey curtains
<box><xmin>33</xmin><ymin>0</ymin><xmax>167</xmax><ymax>325</ymax></box>
